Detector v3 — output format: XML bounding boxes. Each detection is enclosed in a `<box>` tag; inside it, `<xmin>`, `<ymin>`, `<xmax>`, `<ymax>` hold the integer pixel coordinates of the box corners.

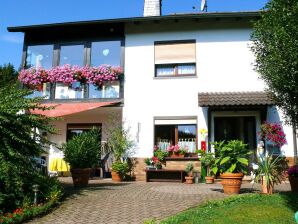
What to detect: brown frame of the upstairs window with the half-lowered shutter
<box><xmin>154</xmin><ymin>39</ymin><xmax>197</xmax><ymax>78</ymax></box>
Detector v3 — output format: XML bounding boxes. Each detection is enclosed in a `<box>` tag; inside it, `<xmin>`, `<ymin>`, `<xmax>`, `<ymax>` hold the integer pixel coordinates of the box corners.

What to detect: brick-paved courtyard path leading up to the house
<box><xmin>26</xmin><ymin>177</ymin><xmax>290</xmax><ymax>224</ymax></box>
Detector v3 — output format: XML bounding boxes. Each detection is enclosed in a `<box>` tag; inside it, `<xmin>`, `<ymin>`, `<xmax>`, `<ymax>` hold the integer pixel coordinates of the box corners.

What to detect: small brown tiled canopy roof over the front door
<box><xmin>199</xmin><ymin>92</ymin><xmax>274</xmax><ymax>107</ymax></box>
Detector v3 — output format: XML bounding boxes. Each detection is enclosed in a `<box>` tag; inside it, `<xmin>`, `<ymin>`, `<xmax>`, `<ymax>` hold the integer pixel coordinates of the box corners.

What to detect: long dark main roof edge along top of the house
<box><xmin>7</xmin><ymin>11</ymin><xmax>260</xmax><ymax>32</ymax></box>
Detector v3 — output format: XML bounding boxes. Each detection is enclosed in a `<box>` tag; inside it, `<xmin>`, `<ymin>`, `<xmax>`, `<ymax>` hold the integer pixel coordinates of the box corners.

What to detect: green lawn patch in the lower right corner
<box><xmin>158</xmin><ymin>193</ymin><xmax>298</xmax><ymax>224</ymax></box>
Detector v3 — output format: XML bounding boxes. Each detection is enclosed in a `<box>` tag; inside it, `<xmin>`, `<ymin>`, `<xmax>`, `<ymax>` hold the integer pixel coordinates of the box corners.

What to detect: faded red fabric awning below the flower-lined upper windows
<box><xmin>31</xmin><ymin>101</ymin><xmax>119</xmax><ymax>117</ymax></box>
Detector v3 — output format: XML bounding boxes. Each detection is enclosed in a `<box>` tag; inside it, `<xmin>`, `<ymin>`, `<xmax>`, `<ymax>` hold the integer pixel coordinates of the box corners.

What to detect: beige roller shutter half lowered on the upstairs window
<box><xmin>155</xmin><ymin>42</ymin><xmax>196</xmax><ymax>64</ymax></box>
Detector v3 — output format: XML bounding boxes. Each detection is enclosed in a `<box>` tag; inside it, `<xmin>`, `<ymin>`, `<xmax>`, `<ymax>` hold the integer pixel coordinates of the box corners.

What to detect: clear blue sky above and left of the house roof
<box><xmin>0</xmin><ymin>0</ymin><xmax>267</xmax><ymax>68</ymax></box>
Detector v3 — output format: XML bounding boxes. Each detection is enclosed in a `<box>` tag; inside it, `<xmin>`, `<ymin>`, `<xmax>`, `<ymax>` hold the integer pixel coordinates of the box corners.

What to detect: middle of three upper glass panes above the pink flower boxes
<box><xmin>60</xmin><ymin>44</ymin><xmax>84</xmax><ymax>66</ymax></box>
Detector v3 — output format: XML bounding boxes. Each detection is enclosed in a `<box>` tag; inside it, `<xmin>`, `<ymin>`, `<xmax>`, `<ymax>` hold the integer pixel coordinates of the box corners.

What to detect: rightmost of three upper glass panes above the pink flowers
<box><xmin>91</xmin><ymin>41</ymin><xmax>121</xmax><ymax>66</ymax></box>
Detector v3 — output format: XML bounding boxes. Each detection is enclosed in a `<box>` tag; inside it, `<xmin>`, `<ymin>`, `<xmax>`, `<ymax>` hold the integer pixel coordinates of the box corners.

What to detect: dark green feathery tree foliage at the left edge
<box><xmin>0</xmin><ymin>64</ymin><xmax>54</xmax><ymax>211</ymax></box>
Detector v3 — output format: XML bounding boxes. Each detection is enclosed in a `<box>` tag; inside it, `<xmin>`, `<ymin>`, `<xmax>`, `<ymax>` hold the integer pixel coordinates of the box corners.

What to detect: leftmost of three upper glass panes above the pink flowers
<box><xmin>26</xmin><ymin>45</ymin><xmax>54</xmax><ymax>69</ymax></box>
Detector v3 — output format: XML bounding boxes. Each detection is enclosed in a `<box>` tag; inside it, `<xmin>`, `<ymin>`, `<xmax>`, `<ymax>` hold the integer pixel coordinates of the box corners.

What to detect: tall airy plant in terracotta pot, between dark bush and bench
<box><xmin>107</xmin><ymin>121</ymin><xmax>134</xmax><ymax>182</ymax></box>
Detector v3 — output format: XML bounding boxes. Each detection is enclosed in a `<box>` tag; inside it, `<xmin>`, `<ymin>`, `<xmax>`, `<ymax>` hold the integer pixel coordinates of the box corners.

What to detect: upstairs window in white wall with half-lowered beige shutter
<box><xmin>154</xmin><ymin>41</ymin><xmax>196</xmax><ymax>77</ymax></box>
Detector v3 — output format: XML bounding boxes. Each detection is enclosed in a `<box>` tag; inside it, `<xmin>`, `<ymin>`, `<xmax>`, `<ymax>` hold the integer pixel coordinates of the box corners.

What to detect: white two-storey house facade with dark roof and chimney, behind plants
<box><xmin>8</xmin><ymin>1</ymin><xmax>297</xmax><ymax>180</ymax></box>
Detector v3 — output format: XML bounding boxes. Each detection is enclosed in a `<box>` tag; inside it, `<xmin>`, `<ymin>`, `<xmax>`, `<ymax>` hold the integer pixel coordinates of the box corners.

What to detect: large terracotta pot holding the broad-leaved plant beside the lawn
<box><xmin>220</xmin><ymin>173</ymin><xmax>244</xmax><ymax>194</ymax></box>
